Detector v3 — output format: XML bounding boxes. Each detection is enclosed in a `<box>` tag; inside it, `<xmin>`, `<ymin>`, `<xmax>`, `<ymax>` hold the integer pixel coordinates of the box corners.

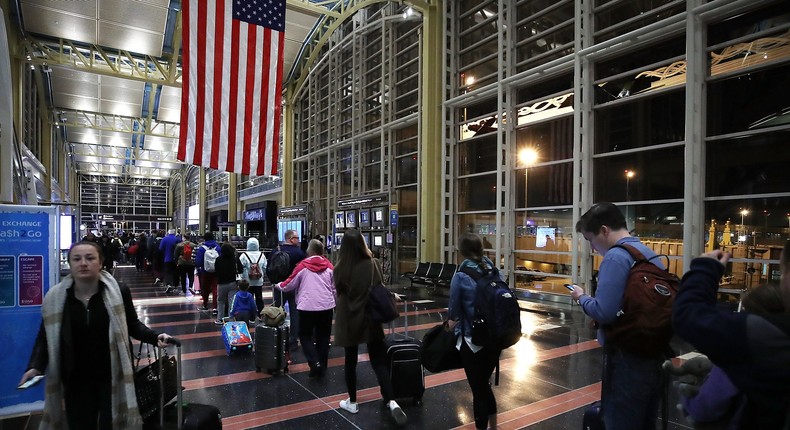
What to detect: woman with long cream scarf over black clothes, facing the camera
<box><xmin>19</xmin><ymin>241</ymin><xmax>171</xmax><ymax>430</ymax></box>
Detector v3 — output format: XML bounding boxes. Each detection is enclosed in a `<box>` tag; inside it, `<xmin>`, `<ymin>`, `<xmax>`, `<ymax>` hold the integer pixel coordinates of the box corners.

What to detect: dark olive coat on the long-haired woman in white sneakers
<box><xmin>334</xmin><ymin>259</ymin><xmax>384</xmax><ymax>346</ymax></box>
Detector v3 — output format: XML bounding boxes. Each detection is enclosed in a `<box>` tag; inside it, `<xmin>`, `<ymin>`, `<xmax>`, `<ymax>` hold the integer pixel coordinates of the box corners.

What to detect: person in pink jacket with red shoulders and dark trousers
<box><xmin>275</xmin><ymin>239</ymin><xmax>336</xmax><ymax>377</ymax></box>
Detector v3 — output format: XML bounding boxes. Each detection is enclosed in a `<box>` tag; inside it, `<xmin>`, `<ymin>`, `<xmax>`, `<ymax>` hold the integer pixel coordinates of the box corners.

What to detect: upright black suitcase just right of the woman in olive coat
<box><xmin>387</xmin><ymin>302</ymin><xmax>425</xmax><ymax>405</ymax></box>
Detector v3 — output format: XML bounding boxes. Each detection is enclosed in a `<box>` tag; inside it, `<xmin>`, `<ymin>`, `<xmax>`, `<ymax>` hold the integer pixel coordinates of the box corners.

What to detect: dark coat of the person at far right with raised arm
<box><xmin>672</xmin><ymin>257</ymin><xmax>790</xmax><ymax>429</ymax></box>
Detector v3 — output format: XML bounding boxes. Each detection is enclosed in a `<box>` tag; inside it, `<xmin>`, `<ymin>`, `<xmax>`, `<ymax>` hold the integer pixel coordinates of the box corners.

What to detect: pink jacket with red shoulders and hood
<box><xmin>279</xmin><ymin>255</ymin><xmax>337</xmax><ymax>311</ymax></box>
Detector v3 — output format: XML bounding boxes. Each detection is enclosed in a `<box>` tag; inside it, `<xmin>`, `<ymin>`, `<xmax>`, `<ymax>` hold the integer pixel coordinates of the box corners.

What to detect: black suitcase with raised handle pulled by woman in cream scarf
<box><xmin>143</xmin><ymin>338</ymin><xmax>222</xmax><ymax>430</ymax></box>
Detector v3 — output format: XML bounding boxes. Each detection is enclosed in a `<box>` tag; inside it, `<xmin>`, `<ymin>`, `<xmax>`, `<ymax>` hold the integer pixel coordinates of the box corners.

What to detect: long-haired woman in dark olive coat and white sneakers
<box><xmin>334</xmin><ymin>229</ymin><xmax>406</xmax><ymax>425</ymax></box>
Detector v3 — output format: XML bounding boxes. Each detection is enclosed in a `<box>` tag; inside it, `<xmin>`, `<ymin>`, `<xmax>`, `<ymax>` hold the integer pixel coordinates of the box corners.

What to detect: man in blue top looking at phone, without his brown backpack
<box><xmin>571</xmin><ymin>202</ymin><xmax>666</xmax><ymax>430</ymax></box>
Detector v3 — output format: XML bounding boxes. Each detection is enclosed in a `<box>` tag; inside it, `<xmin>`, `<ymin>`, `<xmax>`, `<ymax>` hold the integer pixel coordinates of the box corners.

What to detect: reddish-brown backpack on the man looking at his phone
<box><xmin>604</xmin><ymin>245</ymin><xmax>680</xmax><ymax>356</ymax></box>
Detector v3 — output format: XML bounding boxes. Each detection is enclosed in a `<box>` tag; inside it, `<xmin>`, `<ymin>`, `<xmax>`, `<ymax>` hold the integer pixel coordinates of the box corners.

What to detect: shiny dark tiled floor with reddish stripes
<box><xmin>9</xmin><ymin>267</ymin><xmax>690</xmax><ymax>430</ymax></box>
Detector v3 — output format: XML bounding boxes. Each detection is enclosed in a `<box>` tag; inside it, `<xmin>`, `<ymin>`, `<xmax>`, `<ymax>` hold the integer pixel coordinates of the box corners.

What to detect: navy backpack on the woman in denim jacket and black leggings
<box><xmin>461</xmin><ymin>267</ymin><xmax>521</xmax><ymax>349</ymax></box>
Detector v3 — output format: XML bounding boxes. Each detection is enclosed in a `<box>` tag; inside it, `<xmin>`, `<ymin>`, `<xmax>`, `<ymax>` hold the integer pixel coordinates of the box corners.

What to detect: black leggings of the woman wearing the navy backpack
<box><xmin>461</xmin><ymin>339</ymin><xmax>501</xmax><ymax>429</ymax></box>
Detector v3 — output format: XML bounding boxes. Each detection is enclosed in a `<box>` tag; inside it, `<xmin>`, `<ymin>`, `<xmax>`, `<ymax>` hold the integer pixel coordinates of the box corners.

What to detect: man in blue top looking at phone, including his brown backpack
<box><xmin>571</xmin><ymin>203</ymin><xmax>678</xmax><ymax>430</ymax></box>
